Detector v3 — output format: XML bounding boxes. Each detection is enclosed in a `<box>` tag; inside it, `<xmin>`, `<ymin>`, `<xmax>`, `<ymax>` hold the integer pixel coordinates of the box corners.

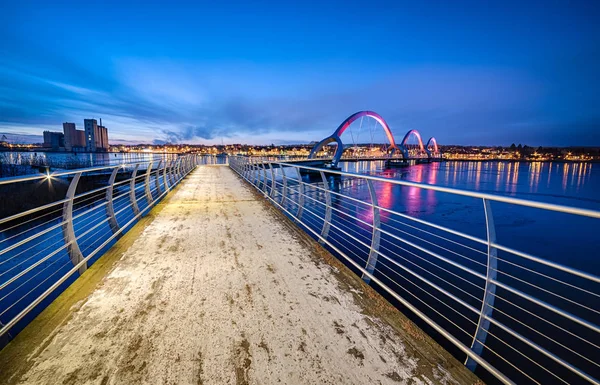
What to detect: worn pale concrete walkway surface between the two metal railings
<box><xmin>0</xmin><ymin>167</ymin><xmax>477</xmax><ymax>385</ymax></box>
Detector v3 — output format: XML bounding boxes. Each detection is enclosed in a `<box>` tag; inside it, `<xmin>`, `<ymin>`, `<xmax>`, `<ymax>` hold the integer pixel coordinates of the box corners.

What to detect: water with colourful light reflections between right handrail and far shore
<box><xmin>340</xmin><ymin>162</ymin><xmax>600</xmax><ymax>209</ymax></box>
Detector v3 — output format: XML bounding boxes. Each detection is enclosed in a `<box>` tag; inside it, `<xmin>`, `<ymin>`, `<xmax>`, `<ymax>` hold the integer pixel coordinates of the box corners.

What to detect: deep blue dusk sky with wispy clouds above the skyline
<box><xmin>0</xmin><ymin>0</ymin><xmax>600</xmax><ymax>146</ymax></box>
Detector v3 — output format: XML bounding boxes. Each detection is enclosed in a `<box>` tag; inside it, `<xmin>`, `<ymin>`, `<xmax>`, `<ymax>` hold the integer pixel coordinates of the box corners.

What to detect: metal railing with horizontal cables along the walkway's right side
<box><xmin>229</xmin><ymin>157</ymin><xmax>600</xmax><ymax>384</ymax></box>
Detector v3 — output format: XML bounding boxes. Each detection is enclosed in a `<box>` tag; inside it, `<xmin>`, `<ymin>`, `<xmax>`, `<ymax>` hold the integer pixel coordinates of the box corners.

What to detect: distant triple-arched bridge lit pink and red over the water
<box><xmin>308</xmin><ymin>111</ymin><xmax>441</xmax><ymax>168</ymax></box>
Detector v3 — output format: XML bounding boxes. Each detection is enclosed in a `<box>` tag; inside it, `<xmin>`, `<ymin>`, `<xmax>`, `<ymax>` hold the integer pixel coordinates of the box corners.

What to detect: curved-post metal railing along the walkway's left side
<box><xmin>0</xmin><ymin>155</ymin><xmax>209</xmax><ymax>342</ymax></box>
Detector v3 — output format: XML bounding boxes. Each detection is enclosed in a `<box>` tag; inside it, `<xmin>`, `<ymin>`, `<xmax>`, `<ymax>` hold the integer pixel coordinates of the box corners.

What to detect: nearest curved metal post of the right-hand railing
<box><xmin>465</xmin><ymin>198</ymin><xmax>498</xmax><ymax>371</ymax></box>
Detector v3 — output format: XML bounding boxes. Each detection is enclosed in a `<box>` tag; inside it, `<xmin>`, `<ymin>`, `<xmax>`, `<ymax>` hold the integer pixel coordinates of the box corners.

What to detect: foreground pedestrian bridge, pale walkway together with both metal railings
<box><xmin>0</xmin><ymin>156</ymin><xmax>600</xmax><ymax>384</ymax></box>
